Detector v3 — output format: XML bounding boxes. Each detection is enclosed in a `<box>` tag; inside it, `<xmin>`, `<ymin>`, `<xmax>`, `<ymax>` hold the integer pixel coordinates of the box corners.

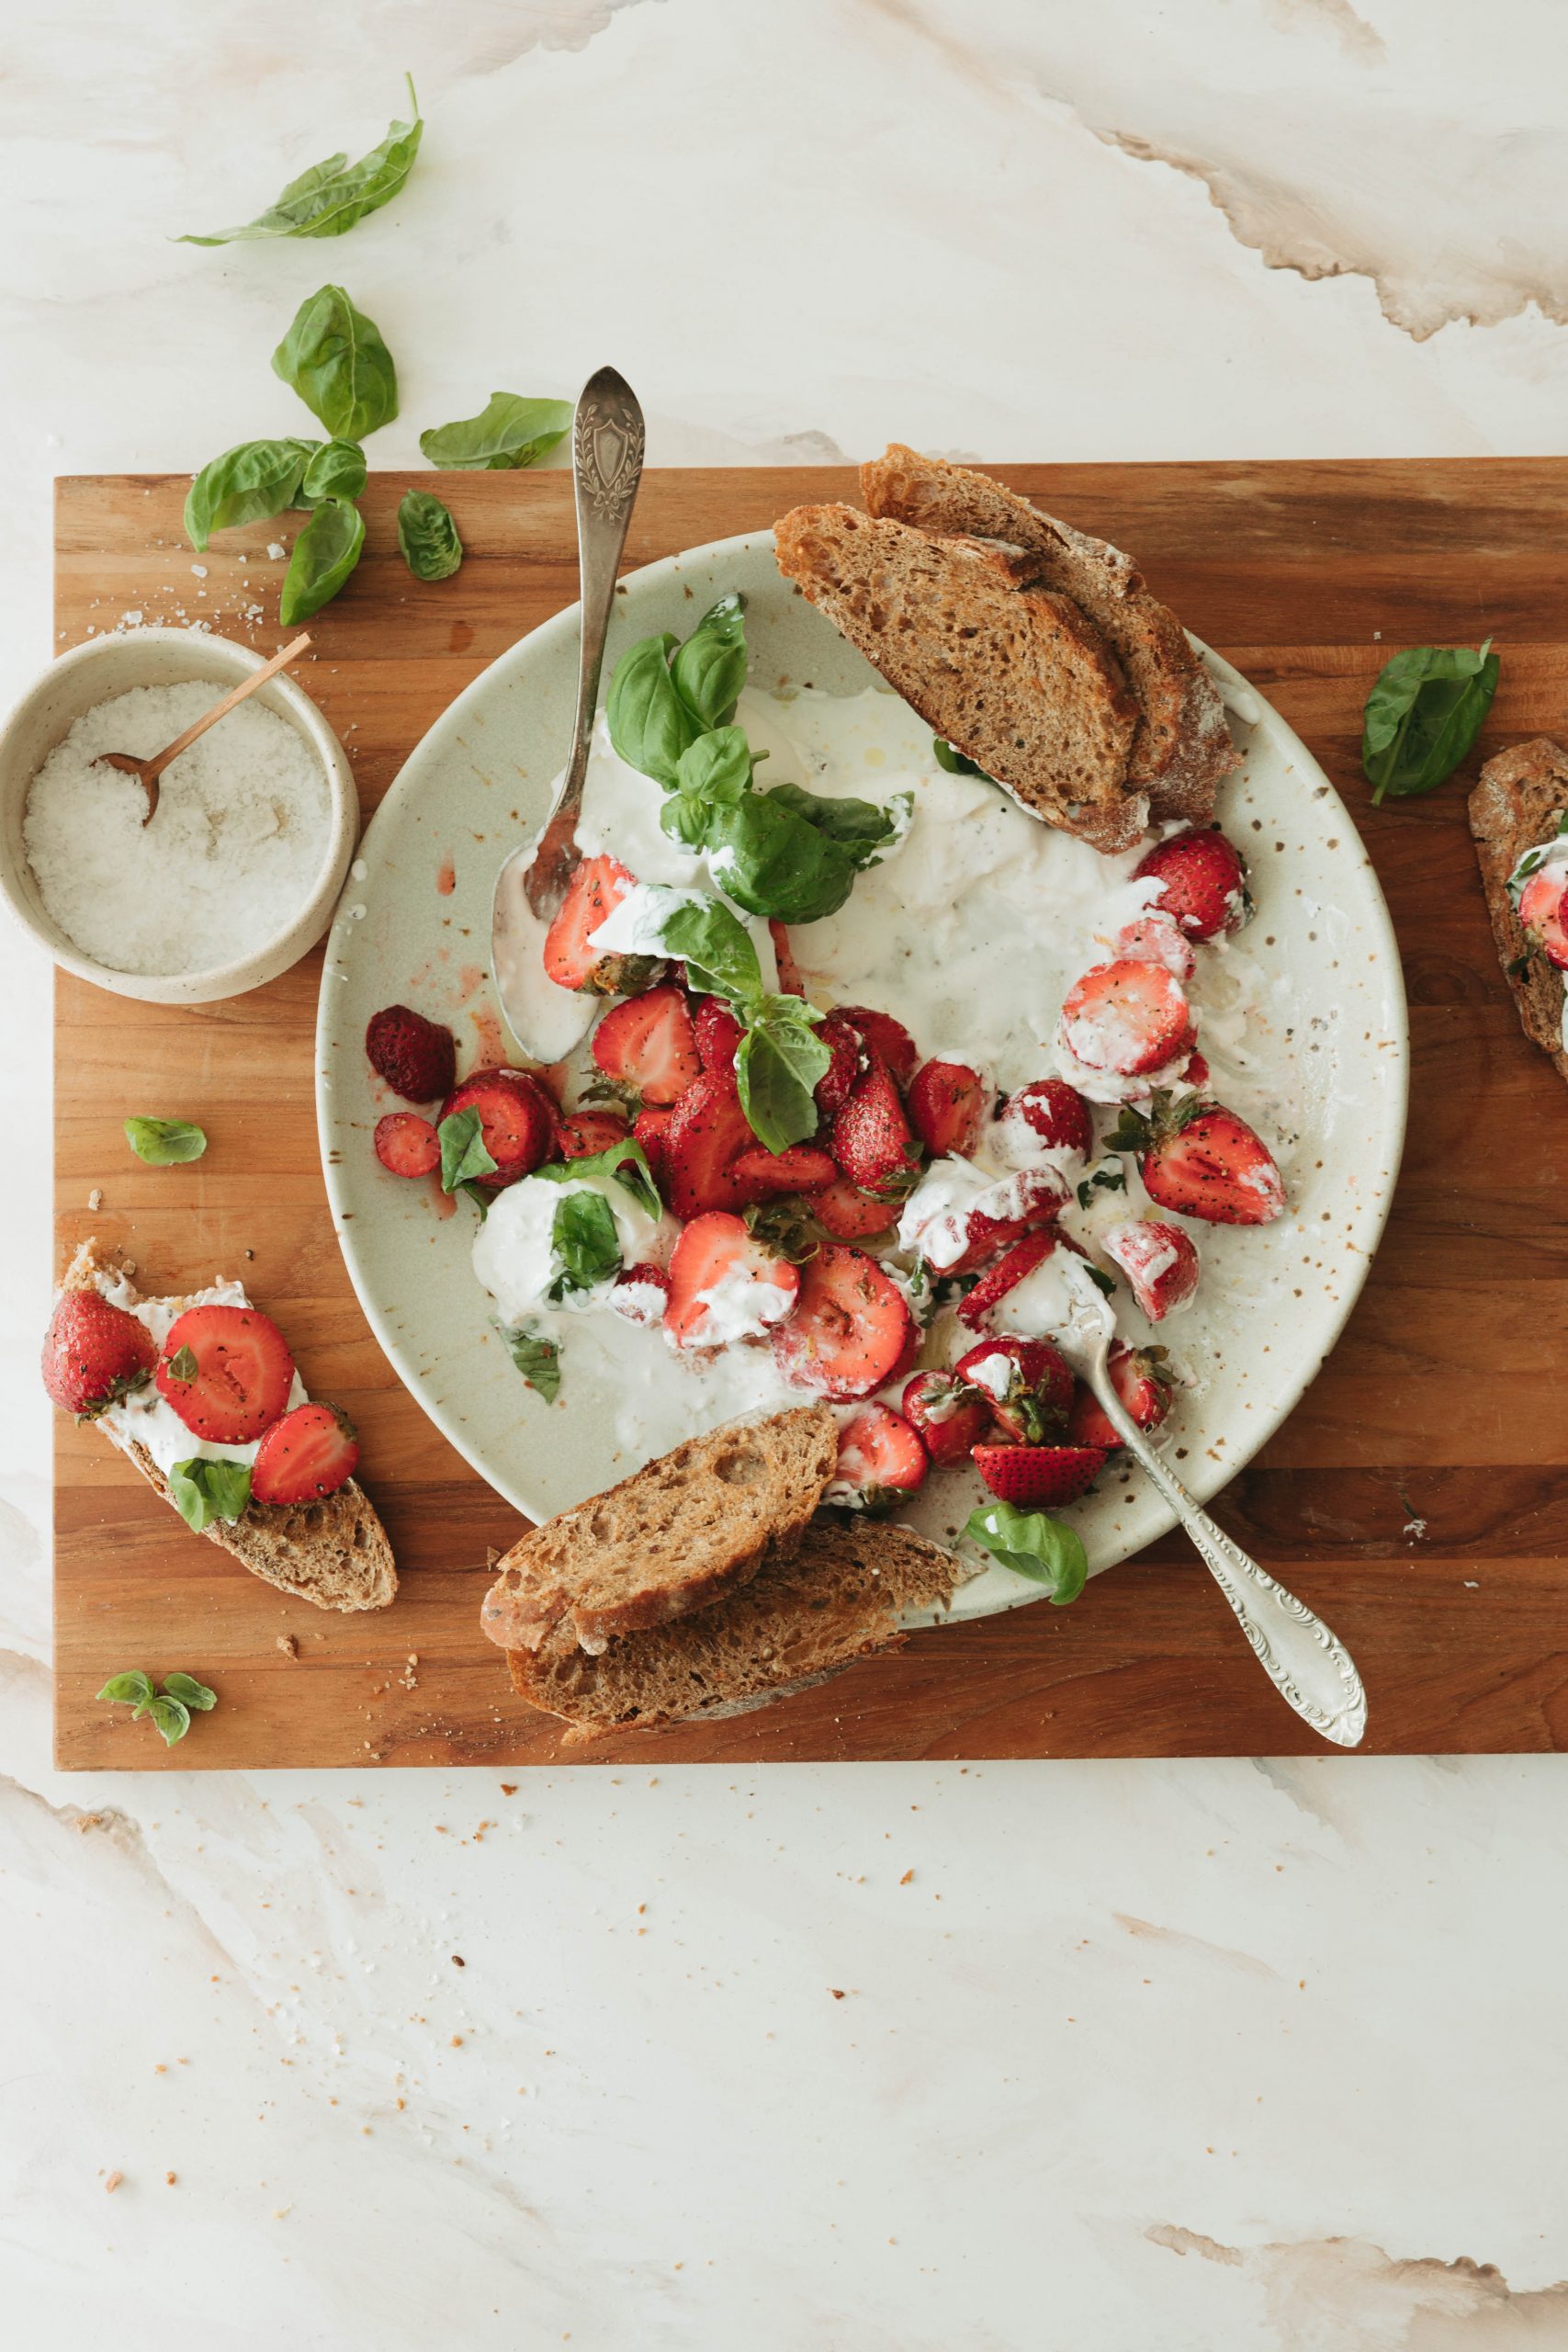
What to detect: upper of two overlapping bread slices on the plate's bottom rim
<box><xmin>479</xmin><ymin>1404</ymin><xmax>840</xmax><ymax>1649</ymax></box>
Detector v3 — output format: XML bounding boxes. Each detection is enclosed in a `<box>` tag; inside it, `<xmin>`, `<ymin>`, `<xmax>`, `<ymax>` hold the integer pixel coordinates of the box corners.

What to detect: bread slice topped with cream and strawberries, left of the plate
<box><xmin>62</xmin><ymin>1239</ymin><xmax>398</xmax><ymax>1611</ymax></box>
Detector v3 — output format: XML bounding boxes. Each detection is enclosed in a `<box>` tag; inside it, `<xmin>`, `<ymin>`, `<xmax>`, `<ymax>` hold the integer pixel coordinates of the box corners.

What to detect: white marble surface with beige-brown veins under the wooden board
<box><xmin>0</xmin><ymin>0</ymin><xmax>1568</xmax><ymax>2352</ymax></box>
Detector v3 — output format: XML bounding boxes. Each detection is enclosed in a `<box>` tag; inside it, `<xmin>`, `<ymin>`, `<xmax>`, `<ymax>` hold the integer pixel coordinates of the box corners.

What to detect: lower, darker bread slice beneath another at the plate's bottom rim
<box><xmin>508</xmin><ymin>1520</ymin><xmax>974</xmax><ymax>1743</ymax></box>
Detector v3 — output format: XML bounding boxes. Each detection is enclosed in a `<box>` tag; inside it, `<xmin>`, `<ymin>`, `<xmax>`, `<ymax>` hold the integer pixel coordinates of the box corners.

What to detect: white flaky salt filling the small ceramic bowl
<box><xmin>21</xmin><ymin>680</ymin><xmax>332</xmax><ymax>974</ymax></box>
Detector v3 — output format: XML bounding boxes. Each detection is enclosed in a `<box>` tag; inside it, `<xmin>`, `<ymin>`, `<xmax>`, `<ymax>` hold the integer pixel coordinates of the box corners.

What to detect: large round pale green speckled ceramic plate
<box><xmin>317</xmin><ymin>534</ymin><xmax>1405</xmax><ymax>1616</ymax></box>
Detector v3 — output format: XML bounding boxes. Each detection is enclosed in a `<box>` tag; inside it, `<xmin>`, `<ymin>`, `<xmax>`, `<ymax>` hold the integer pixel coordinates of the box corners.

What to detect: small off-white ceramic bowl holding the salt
<box><xmin>0</xmin><ymin>628</ymin><xmax>360</xmax><ymax>1004</ymax></box>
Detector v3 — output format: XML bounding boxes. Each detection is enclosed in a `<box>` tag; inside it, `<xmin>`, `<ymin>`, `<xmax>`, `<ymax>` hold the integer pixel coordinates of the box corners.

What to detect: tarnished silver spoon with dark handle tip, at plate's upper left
<box><xmin>491</xmin><ymin>367</ymin><xmax>644</xmax><ymax>1063</ymax></box>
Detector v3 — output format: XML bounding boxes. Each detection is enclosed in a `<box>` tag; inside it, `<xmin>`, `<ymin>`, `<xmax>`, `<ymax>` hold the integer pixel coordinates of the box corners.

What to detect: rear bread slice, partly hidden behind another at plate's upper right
<box><xmin>861</xmin><ymin>442</ymin><xmax>1241</xmax><ymax>826</ymax></box>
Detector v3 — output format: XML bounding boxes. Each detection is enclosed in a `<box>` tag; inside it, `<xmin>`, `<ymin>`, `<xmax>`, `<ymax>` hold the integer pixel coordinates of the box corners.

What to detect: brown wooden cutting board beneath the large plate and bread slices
<box><xmin>54</xmin><ymin>458</ymin><xmax>1568</xmax><ymax>1771</ymax></box>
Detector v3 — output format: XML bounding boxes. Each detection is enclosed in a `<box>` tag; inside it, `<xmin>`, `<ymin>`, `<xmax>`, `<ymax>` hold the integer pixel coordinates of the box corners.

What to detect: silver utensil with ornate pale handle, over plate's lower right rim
<box><xmin>1051</xmin><ymin>1265</ymin><xmax>1366</xmax><ymax>1747</ymax></box>
